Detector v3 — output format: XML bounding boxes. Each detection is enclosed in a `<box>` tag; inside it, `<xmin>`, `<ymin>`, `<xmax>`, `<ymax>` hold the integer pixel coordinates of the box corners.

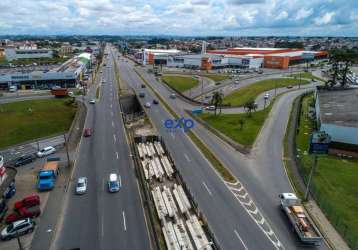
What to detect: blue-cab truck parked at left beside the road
<box><xmin>37</xmin><ymin>161</ymin><xmax>58</xmax><ymax>191</ymax></box>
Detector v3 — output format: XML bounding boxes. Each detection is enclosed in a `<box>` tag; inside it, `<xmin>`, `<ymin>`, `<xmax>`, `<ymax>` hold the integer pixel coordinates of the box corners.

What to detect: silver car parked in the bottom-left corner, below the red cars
<box><xmin>1</xmin><ymin>218</ymin><xmax>36</xmax><ymax>240</ymax></box>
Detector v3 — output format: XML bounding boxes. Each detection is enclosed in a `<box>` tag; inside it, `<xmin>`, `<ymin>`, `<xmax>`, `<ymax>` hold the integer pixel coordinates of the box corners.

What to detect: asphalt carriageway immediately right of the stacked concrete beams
<box><xmin>116</xmin><ymin>48</ymin><xmax>284</xmax><ymax>249</ymax></box>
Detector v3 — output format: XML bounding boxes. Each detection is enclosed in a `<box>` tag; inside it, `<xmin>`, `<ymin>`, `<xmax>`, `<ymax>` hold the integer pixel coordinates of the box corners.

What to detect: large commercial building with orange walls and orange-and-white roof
<box><xmin>208</xmin><ymin>47</ymin><xmax>327</xmax><ymax>69</ymax></box>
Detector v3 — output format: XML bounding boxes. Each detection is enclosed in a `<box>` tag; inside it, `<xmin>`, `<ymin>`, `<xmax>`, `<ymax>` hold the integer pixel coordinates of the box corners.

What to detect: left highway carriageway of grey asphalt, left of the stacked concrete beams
<box><xmin>51</xmin><ymin>47</ymin><xmax>150</xmax><ymax>250</ymax></box>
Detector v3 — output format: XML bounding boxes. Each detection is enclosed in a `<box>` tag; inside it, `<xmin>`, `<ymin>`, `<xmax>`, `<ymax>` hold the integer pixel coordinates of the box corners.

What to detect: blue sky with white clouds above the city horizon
<box><xmin>0</xmin><ymin>0</ymin><xmax>358</xmax><ymax>36</ymax></box>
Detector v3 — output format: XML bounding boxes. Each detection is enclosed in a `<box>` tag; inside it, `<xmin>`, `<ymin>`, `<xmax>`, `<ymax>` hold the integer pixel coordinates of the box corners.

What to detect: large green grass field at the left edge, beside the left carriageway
<box><xmin>0</xmin><ymin>99</ymin><xmax>77</xmax><ymax>148</ymax></box>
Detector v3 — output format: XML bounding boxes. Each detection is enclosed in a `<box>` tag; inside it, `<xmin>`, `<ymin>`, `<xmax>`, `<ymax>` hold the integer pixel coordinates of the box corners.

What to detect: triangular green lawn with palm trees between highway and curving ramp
<box><xmin>199</xmin><ymin>106</ymin><xmax>271</xmax><ymax>146</ymax></box>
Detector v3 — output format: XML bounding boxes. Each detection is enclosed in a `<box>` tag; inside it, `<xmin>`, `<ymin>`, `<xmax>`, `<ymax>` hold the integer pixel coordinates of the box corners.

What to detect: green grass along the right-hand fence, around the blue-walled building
<box><xmin>296</xmin><ymin>95</ymin><xmax>358</xmax><ymax>246</ymax></box>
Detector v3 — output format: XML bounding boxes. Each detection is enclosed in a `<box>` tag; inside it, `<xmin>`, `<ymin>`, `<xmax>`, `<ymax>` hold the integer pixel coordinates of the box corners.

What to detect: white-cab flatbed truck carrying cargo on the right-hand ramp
<box><xmin>279</xmin><ymin>193</ymin><xmax>322</xmax><ymax>246</ymax></box>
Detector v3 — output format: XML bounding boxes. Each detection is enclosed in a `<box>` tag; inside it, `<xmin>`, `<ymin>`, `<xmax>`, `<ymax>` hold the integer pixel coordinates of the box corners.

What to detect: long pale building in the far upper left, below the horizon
<box><xmin>5</xmin><ymin>47</ymin><xmax>53</xmax><ymax>61</ymax></box>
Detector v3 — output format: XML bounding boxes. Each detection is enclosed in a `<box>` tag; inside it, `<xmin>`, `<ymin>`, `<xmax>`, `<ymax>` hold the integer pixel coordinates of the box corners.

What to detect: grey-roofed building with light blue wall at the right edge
<box><xmin>315</xmin><ymin>88</ymin><xmax>358</xmax><ymax>152</ymax></box>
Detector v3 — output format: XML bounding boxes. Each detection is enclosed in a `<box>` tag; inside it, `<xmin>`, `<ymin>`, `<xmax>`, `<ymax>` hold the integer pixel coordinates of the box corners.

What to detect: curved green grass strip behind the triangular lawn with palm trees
<box><xmin>224</xmin><ymin>78</ymin><xmax>309</xmax><ymax>106</ymax></box>
